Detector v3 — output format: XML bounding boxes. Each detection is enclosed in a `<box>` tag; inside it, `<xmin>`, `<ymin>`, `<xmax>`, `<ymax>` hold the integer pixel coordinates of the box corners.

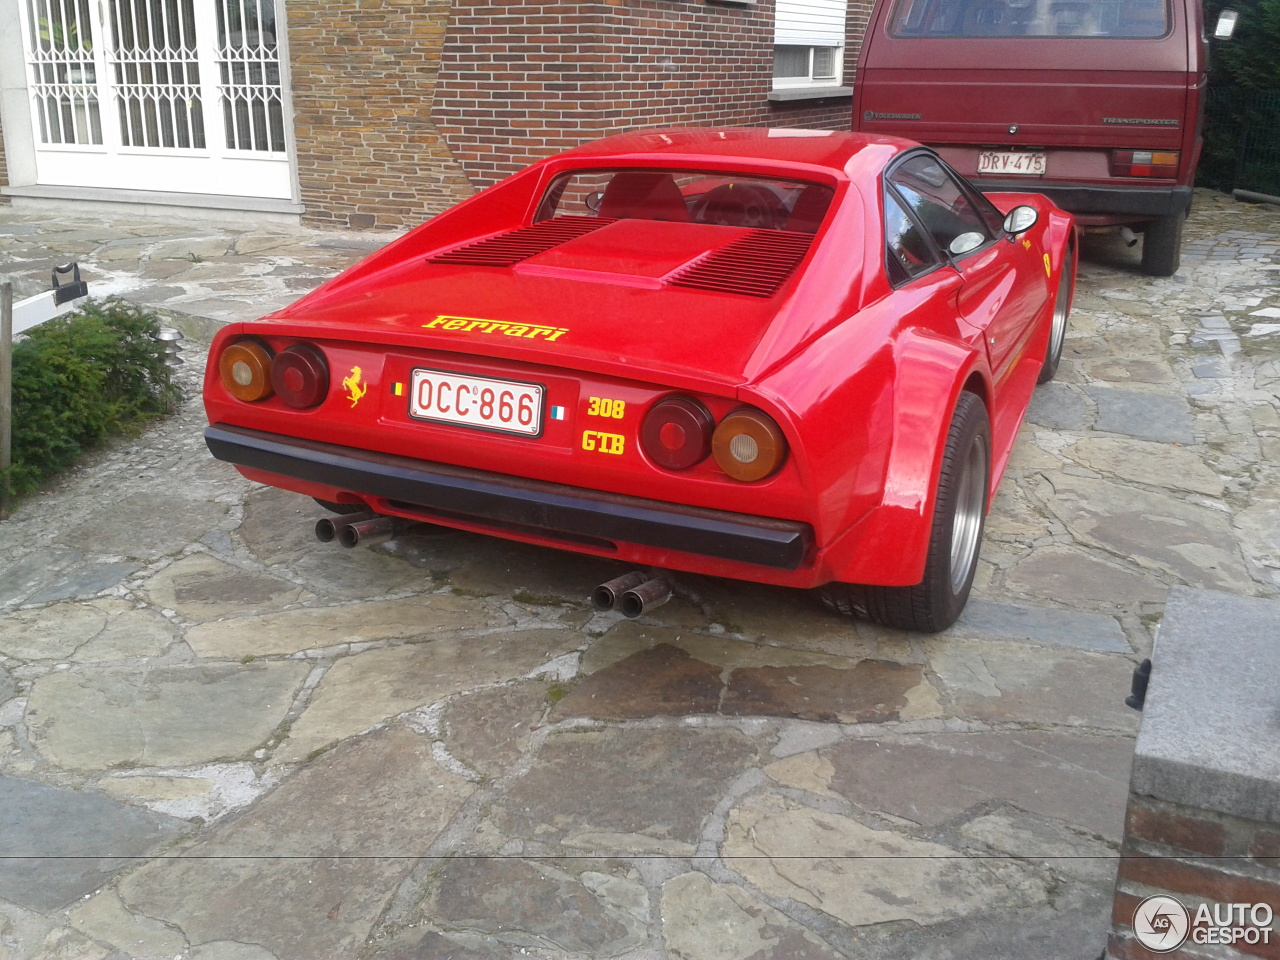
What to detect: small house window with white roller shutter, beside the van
<box><xmin>773</xmin><ymin>0</ymin><xmax>849</xmax><ymax>90</ymax></box>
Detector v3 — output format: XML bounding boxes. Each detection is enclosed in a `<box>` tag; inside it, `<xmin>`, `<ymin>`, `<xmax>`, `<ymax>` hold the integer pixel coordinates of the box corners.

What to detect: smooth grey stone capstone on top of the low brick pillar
<box><xmin>1133</xmin><ymin>588</ymin><xmax>1280</xmax><ymax>823</ymax></box>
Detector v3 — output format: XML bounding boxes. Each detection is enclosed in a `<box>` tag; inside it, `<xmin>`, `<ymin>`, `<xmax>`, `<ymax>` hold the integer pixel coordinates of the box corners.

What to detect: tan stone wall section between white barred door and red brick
<box><xmin>285</xmin><ymin>0</ymin><xmax>472</xmax><ymax>229</ymax></box>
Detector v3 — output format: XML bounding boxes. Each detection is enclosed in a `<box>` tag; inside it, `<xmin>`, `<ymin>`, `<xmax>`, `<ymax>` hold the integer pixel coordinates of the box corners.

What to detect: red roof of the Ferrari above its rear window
<box><xmin>554</xmin><ymin>127</ymin><xmax>918</xmax><ymax>177</ymax></box>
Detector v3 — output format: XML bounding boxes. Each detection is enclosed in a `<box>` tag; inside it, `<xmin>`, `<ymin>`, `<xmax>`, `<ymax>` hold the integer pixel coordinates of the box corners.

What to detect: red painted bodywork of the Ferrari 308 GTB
<box><xmin>205</xmin><ymin>131</ymin><xmax>1074</xmax><ymax>588</ymax></box>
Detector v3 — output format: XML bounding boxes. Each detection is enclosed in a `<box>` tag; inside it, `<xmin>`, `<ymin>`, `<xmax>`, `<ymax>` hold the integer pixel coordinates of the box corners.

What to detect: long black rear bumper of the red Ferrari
<box><xmin>205</xmin><ymin>424</ymin><xmax>813</xmax><ymax>570</ymax></box>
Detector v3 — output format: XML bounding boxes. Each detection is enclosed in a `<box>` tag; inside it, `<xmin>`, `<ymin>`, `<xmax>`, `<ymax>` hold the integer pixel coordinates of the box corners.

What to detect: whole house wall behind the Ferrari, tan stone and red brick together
<box><xmin>287</xmin><ymin>0</ymin><xmax>870</xmax><ymax>229</ymax></box>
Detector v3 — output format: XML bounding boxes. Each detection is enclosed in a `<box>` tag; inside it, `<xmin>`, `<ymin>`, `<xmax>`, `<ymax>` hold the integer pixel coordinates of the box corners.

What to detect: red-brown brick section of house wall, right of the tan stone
<box><xmin>434</xmin><ymin>0</ymin><xmax>870</xmax><ymax>187</ymax></box>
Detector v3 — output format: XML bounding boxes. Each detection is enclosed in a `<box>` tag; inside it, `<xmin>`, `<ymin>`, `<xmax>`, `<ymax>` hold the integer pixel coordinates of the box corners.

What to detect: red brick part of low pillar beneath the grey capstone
<box><xmin>1106</xmin><ymin>794</ymin><xmax>1280</xmax><ymax>960</ymax></box>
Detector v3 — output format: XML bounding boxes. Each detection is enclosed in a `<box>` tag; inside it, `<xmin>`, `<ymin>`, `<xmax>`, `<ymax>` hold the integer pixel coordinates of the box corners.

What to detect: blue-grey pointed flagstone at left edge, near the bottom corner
<box><xmin>0</xmin><ymin>774</ymin><xmax>187</xmax><ymax>911</ymax></box>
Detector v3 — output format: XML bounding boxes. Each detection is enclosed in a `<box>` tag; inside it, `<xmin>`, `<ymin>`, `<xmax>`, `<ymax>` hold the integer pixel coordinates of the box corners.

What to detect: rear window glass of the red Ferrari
<box><xmin>535</xmin><ymin>169</ymin><xmax>835</xmax><ymax>233</ymax></box>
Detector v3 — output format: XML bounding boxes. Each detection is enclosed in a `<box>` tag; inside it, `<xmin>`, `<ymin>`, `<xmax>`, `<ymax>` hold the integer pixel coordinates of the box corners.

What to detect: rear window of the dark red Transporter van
<box><xmin>890</xmin><ymin>0</ymin><xmax>1169</xmax><ymax>37</ymax></box>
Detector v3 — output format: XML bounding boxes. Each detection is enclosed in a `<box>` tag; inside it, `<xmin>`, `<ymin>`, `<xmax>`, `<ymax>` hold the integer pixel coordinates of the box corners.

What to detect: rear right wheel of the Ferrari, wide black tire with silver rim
<box><xmin>818</xmin><ymin>393</ymin><xmax>991</xmax><ymax>634</ymax></box>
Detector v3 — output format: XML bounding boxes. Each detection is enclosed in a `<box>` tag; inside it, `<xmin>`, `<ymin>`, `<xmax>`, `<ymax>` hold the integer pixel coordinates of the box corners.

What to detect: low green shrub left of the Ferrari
<box><xmin>0</xmin><ymin>300</ymin><xmax>179</xmax><ymax>494</ymax></box>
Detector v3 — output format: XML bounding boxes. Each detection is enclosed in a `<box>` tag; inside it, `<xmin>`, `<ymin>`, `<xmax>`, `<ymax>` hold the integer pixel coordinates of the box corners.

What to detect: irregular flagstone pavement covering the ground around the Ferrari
<box><xmin>0</xmin><ymin>192</ymin><xmax>1280</xmax><ymax>960</ymax></box>
